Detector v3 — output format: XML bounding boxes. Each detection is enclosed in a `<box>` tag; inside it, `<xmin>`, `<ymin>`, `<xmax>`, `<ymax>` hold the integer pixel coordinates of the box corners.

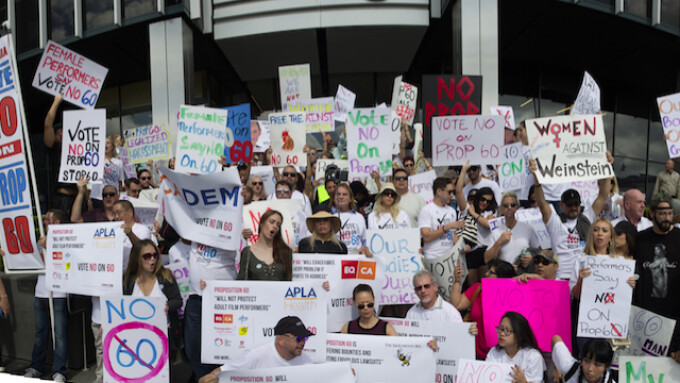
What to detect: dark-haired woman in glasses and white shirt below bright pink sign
<box><xmin>486</xmin><ymin>311</ymin><xmax>545</xmax><ymax>383</ymax></box>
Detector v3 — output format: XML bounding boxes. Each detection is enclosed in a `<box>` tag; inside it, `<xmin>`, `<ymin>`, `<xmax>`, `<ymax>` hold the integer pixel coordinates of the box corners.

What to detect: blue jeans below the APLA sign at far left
<box><xmin>31</xmin><ymin>298</ymin><xmax>68</xmax><ymax>376</ymax></box>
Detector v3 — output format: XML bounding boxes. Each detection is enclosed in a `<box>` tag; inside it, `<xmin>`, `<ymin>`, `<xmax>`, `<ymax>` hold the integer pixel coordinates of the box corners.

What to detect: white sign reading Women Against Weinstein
<box><xmin>526</xmin><ymin>115</ymin><xmax>614</xmax><ymax>184</ymax></box>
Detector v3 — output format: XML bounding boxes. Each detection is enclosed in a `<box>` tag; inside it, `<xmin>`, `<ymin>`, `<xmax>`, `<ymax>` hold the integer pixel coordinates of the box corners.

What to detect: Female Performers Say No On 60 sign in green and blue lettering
<box><xmin>175</xmin><ymin>105</ymin><xmax>228</xmax><ymax>174</ymax></box>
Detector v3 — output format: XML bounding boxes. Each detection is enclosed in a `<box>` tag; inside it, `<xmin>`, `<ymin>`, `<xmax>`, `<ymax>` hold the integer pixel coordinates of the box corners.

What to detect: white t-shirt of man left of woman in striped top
<box><xmin>418</xmin><ymin>202</ymin><xmax>458</xmax><ymax>259</ymax></box>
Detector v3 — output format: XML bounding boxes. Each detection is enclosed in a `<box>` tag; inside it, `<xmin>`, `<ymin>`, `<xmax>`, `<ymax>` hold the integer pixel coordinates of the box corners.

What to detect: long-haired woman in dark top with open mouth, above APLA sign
<box><xmin>236</xmin><ymin>210</ymin><xmax>292</xmax><ymax>281</ymax></box>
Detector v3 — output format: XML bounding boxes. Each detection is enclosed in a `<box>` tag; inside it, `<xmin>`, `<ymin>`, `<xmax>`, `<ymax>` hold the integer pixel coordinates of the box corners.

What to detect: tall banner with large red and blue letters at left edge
<box><xmin>0</xmin><ymin>34</ymin><xmax>45</xmax><ymax>271</ymax></box>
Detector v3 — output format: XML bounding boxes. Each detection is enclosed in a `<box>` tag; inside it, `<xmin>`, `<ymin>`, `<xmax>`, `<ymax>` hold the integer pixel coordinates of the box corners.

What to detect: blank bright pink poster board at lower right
<box><xmin>482</xmin><ymin>279</ymin><xmax>571</xmax><ymax>351</ymax></box>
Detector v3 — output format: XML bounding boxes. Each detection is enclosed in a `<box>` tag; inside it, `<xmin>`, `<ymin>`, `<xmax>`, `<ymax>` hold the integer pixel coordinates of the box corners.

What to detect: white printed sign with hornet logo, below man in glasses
<box><xmin>326</xmin><ymin>334</ymin><xmax>437</xmax><ymax>383</ymax></box>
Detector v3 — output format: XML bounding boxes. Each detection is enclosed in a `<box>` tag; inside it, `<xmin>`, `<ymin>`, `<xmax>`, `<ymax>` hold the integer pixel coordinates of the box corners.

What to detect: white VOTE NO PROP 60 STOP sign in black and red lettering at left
<box><xmin>59</xmin><ymin>109</ymin><xmax>106</xmax><ymax>184</ymax></box>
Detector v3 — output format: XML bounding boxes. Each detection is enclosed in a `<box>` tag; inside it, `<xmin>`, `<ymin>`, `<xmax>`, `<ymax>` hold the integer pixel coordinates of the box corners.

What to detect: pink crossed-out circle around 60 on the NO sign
<box><xmin>103</xmin><ymin>322</ymin><xmax>168</xmax><ymax>383</ymax></box>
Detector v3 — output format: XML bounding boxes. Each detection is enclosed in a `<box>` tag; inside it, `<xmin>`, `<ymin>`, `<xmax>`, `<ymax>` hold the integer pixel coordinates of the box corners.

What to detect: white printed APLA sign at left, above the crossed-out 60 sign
<box><xmin>45</xmin><ymin>222</ymin><xmax>125</xmax><ymax>296</ymax></box>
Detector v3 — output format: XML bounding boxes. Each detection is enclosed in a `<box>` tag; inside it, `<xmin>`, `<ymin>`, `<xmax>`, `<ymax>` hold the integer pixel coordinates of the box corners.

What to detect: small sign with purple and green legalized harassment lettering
<box><xmin>121</xmin><ymin>125</ymin><xmax>172</xmax><ymax>164</ymax></box>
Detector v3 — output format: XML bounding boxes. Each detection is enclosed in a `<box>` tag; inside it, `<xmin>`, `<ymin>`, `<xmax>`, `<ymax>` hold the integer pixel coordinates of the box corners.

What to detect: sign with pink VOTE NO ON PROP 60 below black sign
<box><xmin>432</xmin><ymin>115</ymin><xmax>505</xmax><ymax>166</ymax></box>
